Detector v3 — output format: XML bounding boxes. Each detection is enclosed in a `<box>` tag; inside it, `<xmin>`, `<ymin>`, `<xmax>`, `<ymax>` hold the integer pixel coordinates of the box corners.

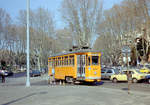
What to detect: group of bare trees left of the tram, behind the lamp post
<box><xmin>0</xmin><ymin>8</ymin><xmax>55</xmax><ymax>69</ymax></box>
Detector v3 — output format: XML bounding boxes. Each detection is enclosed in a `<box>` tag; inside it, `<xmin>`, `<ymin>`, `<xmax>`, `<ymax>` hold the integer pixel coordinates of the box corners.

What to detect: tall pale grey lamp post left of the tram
<box><xmin>26</xmin><ymin>0</ymin><xmax>30</xmax><ymax>87</ymax></box>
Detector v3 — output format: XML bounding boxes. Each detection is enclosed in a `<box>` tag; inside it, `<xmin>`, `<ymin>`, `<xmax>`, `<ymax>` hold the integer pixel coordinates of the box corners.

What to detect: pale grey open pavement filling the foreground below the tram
<box><xmin>0</xmin><ymin>85</ymin><xmax>150</xmax><ymax>105</ymax></box>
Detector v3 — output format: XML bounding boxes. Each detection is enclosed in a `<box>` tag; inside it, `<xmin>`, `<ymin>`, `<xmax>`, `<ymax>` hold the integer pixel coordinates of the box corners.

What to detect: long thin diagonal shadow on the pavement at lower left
<box><xmin>1</xmin><ymin>92</ymin><xmax>48</xmax><ymax>105</ymax></box>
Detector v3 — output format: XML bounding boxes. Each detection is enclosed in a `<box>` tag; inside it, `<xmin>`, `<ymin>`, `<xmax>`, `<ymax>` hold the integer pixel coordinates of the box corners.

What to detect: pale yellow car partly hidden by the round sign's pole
<box><xmin>110</xmin><ymin>70</ymin><xmax>146</xmax><ymax>83</ymax></box>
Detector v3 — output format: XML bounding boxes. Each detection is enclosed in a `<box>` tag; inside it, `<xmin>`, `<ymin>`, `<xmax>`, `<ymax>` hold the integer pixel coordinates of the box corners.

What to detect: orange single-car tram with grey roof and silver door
<box><xmin>48</xmin><ymin>50</ymin><xmax>101</xmax><ymax>82</ymax></box>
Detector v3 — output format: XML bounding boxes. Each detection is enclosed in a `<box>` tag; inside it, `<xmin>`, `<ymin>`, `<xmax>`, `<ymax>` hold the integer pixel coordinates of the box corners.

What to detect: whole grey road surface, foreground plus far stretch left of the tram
<box><xmin>0</xmin><ymin>73</ymin><xmax>150</xmax><ymax>105</ymax></box>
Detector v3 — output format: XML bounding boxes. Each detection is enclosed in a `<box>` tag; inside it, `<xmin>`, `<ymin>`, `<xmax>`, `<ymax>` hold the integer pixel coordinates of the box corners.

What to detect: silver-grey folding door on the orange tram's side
<box><xmin>77</xmin><ymin>55</ymin><xmax>86</xmax><ymax>78</ymax></box>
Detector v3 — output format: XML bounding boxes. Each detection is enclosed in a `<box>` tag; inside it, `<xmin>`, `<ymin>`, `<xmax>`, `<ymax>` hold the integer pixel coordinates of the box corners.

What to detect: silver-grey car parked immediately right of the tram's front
<box><xmin>101</xmin><ymin>68</ymin><xmax>119</xmax><ymax>79</ymax></box>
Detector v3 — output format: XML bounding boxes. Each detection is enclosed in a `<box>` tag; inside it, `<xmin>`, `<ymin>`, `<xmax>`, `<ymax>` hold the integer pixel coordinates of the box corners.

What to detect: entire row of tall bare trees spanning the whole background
<box><xmin>0</xmin><ymin>0</ymin><xmax>150</xmax><ymax>66</ymax></box>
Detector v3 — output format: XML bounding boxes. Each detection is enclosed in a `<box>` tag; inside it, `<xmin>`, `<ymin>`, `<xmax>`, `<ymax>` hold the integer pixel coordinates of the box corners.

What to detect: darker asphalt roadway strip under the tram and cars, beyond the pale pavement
<box><xmin>1</xmin><ymin>72</ymin><xmax>150</xmax><ymax>91</ymax></box>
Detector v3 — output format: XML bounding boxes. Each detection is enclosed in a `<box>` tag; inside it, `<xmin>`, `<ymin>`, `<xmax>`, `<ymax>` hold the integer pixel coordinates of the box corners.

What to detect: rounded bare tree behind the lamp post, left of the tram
<box><xmin>18</xmin><ymin>8</ymin><xmax>55</xmax><ymax>69</ymax></box>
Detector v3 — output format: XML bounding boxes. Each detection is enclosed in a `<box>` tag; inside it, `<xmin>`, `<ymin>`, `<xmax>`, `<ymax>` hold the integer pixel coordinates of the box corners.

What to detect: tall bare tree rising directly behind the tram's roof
<box><xmin>61</xmin><ymin>0</ymin><xmax>102</xmax><ymax>47</ymax></box>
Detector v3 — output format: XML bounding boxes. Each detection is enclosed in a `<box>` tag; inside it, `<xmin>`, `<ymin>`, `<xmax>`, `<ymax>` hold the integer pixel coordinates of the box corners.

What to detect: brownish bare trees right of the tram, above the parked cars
<box><xmin>95</xmin><ymin>0</ymin><xmax>150</xmax><ymax>64</ymax></box>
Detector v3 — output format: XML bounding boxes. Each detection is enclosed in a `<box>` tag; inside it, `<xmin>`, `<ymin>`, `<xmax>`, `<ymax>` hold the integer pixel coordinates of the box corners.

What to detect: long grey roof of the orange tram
<box><xmin>49</xmin><ymin>50</ymin><xmax>100</xmax><ymax>57</ymax></box>
